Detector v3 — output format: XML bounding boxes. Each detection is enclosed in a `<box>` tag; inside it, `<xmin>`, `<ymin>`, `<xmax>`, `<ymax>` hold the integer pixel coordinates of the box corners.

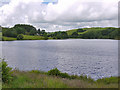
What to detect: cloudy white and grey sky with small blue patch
<box><xmin>0</xmin><ymin>0</ymin><xmax>119</xmax><ymax>31</ymax></box>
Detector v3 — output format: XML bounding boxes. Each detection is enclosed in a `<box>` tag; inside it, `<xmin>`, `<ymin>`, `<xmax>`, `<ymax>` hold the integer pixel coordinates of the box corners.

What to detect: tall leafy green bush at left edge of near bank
<box><xmin>2</xmin><ymin>60</ymin><xmax>12</xmax><ymax>83</ymax></box>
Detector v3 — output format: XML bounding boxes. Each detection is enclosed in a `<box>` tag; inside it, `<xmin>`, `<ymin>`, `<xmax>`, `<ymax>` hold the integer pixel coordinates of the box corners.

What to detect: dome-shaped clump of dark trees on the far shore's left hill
<box><xmin>2</xmin><ymin>24</ymin><xmax>37</xmax><ymax>38</ymax></box>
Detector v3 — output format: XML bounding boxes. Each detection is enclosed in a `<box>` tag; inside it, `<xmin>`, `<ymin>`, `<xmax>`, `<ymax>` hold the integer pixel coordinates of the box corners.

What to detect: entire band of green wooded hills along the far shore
<box><xmin>2</xmin><ymin>24</ymin><xmax>120</xmax><ymax>40</ymax></box>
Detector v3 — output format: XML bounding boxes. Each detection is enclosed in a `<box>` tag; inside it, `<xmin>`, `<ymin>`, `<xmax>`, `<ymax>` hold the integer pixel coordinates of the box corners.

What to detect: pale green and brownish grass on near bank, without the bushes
<box><xmin>2</xmin><ymin>70</ymin><xmax>118</xmax><ymax>88</ymax></box>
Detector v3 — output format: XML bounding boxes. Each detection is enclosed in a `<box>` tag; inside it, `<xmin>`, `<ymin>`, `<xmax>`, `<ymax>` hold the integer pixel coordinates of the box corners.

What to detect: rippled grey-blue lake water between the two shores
<box><xmin>2</xmin><ymin>39</ymin><xmax>118</xmax><ymax>79</ymax></box>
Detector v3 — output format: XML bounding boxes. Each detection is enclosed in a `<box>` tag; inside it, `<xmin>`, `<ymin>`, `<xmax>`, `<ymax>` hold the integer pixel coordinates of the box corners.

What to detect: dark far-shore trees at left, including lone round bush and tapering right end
<box><xmin>2</xmin><ymin>24</ymin><xmax>47</xmax><ymax>39</ymax></box>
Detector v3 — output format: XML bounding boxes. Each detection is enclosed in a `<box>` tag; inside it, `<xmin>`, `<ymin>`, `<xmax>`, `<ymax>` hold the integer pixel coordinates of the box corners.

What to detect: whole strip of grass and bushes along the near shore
<box><xmin>2</xmin><ymin>61</ymin><xmax>118</xmax><ymax>88</ymax></box>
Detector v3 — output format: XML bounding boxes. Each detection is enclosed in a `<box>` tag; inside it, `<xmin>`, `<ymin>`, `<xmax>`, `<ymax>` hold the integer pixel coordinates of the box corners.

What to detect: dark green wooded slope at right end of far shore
<box><xmin>82</xmin><ymin>28</ymin><xmax>120</xmax><ymax>39</ymax></box>
